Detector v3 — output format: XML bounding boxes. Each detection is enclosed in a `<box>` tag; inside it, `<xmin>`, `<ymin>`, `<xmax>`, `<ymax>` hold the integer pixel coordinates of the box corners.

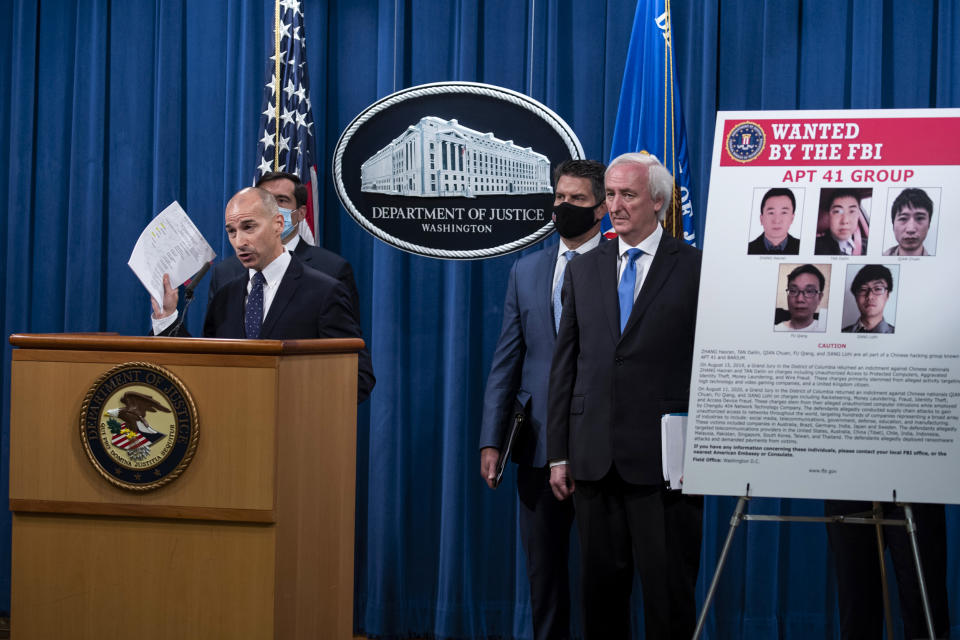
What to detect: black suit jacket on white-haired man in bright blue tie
<box><xmin>547</xmin><ymin>234</ymin><xmax>700</xmax><ymax>486</ymax></box>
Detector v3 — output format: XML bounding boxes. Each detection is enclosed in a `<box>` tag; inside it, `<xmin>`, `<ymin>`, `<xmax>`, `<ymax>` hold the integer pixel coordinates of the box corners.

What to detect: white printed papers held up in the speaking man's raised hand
<box><xmin>127</xmin><ymin>201</ymin><xmax>216</xmax><ymax>302</ymax></box>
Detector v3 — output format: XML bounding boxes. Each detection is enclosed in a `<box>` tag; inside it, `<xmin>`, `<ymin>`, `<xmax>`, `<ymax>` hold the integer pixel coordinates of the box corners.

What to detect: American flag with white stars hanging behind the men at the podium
<box><xmin>254</xmin><ymin>0</ymin><xmax>319</xmax><ymax>244</ymax></box>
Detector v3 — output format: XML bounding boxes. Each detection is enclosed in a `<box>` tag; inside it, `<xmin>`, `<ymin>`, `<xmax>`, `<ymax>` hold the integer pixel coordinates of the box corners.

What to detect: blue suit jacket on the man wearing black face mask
<box><xmin>480</xmin><ymin>243</ymin><xmax>557</xmax><ymax>467</ymax></box>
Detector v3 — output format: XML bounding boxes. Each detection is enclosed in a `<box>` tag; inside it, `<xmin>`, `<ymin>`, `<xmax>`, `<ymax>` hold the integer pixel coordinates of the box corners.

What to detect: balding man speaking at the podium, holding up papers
<box><xmin>151</xmin><ymin>187</ymin><xmax>375</xmax><ymax>401</ymax></box>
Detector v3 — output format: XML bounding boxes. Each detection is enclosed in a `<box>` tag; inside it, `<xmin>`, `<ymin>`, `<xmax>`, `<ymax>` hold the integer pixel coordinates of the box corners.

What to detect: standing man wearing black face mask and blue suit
<box><xmin>480</xmin><ymin>160</ymin><xmax>607</xmax><ymax>640</ymax></box>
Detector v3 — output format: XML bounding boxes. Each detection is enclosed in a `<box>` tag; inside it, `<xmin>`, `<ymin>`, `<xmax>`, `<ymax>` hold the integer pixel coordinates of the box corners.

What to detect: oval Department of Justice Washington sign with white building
<box><xmin>333</xmin><ymin>82</ymin><xmax>583</xmax><ymax>260</ymax></box>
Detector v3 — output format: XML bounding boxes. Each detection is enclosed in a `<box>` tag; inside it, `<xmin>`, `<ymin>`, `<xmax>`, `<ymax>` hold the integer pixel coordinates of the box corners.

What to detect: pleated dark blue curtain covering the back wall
<box><xmin>0</xmin><ymin>0</ymin><xmax>960</xmax><ymax>640</ymax></box>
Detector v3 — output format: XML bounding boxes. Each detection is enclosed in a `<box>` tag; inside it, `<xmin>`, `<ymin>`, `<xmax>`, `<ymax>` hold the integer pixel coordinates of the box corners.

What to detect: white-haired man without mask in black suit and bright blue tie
<box><xmin>547</xmin><ymin>153</ymin><xmax>703</xmax><ymax>639</ymax></box>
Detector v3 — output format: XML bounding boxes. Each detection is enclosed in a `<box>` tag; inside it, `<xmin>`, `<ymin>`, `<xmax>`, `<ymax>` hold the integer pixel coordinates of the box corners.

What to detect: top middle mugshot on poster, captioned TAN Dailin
<box><xmin>813</xmin><ymin>188</ymin><xmax>873</xmax><ymax>256</ymax></box>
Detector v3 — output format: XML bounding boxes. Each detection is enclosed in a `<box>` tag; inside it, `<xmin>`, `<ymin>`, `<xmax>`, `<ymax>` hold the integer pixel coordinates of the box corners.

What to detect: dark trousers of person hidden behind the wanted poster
<box><xmin>824</xmin><ymin>500</ymin><xmax>950</xmax><ymax>640</ymax></box>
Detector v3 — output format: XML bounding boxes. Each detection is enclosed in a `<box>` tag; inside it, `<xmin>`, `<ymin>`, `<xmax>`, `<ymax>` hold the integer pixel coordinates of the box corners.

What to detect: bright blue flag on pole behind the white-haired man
<box><xmin>603</xmin><ymin>0</ymin><xmax>696</xmax><ymax>245</ymax></box>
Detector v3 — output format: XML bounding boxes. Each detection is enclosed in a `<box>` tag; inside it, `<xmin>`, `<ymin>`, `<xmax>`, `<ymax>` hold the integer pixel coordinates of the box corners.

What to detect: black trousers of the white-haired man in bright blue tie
<box><xmin>573</xmin><ymin>469</ymin><xmax>703</xmax><ymax>640</ymax></box>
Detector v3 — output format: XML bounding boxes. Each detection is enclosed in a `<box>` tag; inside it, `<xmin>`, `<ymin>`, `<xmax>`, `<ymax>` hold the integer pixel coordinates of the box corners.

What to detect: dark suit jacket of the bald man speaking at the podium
<box><xmin>171</xmin><ymin>255</ymin><xmax>376</xmax><ymax>402</ymax></box>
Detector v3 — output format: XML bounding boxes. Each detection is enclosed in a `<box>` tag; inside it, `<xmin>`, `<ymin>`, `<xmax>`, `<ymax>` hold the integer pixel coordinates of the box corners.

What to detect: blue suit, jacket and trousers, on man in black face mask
<box><xmin>480</xmin><ymin>244</ymin><xmax>573</xmax><ymax>640</ymax></box>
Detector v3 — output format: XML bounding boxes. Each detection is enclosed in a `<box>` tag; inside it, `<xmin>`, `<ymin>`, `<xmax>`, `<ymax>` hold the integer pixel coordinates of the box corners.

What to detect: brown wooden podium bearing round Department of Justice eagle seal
<box><xmin>10</xmin><ymin>334</ymin><xmax>363</xmax><ymax>640</ymax></box>
